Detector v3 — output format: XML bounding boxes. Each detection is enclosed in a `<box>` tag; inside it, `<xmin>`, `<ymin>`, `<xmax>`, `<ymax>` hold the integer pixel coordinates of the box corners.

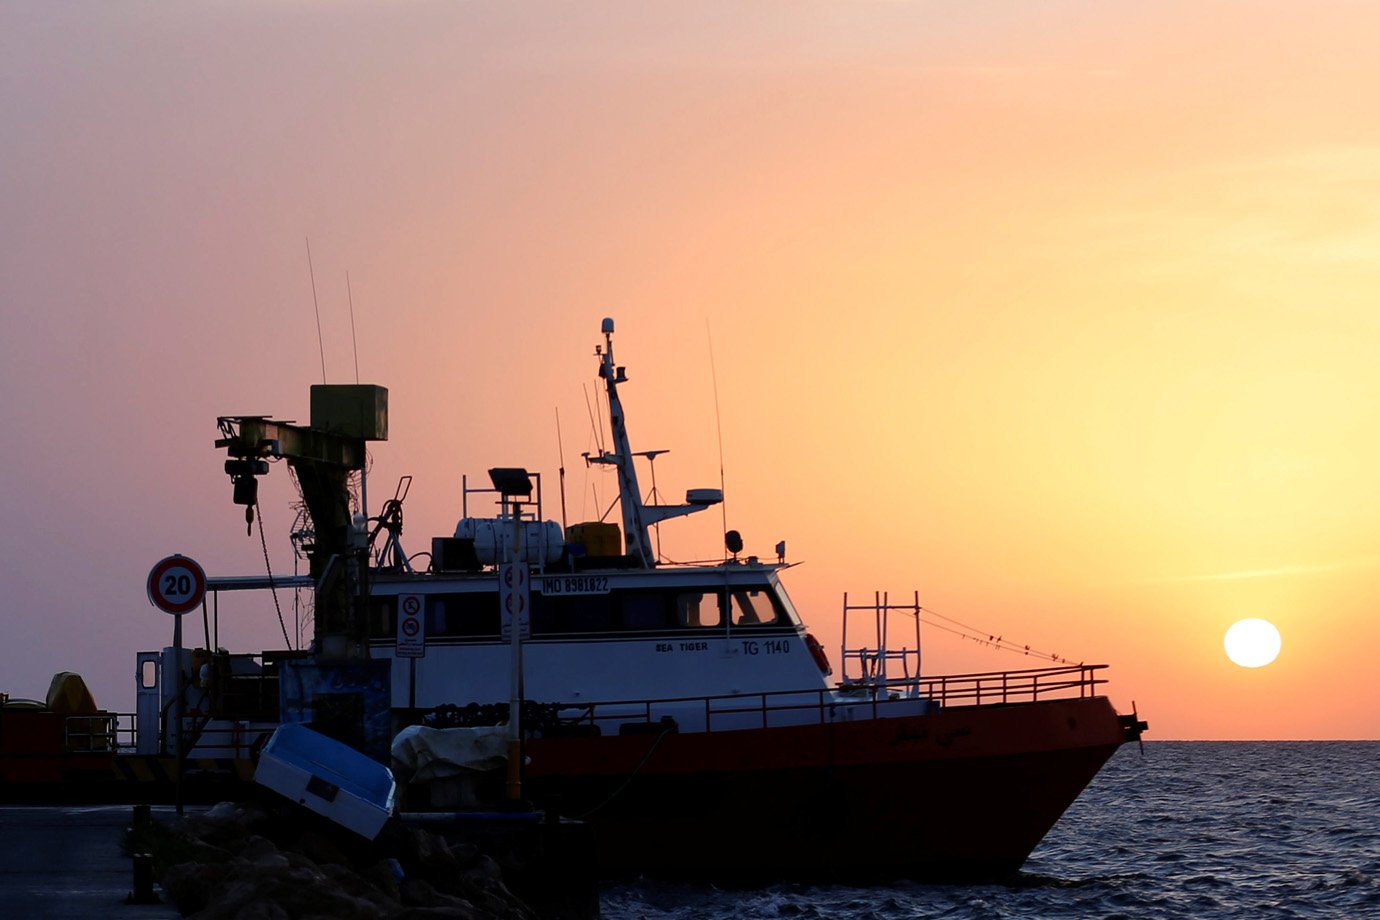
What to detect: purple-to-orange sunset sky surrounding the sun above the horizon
<box><xmin>0</xmin><ymin>0</ymin><xmax>1380</xmax><ymax>739</ymax></box>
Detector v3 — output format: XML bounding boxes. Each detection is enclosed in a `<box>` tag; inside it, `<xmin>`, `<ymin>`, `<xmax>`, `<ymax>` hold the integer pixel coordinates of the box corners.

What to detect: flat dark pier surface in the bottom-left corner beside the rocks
<box><xmin>0</xmin><ymin>806</ymin><xmax>178</xmax><ymax>920</ymax></box>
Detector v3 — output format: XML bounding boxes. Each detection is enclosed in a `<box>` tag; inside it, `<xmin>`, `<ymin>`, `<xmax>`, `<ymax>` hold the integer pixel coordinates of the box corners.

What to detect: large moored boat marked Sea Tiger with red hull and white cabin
<box><xmin>2</xmin><ymin>320</ymin><xmax>1145</xmax><ymax>880</ymax></box>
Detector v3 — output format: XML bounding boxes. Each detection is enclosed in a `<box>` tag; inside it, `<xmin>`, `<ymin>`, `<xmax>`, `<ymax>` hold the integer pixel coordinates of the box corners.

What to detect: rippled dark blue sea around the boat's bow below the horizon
<box><xmin>600</xmin><ymin>741</ymin><xmax>1380</xmax><ymax>920</ymax></box>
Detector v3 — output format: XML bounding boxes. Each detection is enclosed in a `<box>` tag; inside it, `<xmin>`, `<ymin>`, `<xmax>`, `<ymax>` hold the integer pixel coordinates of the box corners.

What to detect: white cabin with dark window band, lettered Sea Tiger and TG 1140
<box><xmin>371</xmin><ymin>563</ymin><xmax>827</xmax><ymax>709</ymax></box>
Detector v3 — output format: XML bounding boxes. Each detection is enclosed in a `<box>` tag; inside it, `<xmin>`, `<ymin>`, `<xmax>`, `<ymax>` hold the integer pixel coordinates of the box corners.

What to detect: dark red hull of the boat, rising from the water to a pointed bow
<box><xmin>527</xmin><ymin>697</ymin><xmax>1127</xmax><ymax>880</ymax></box>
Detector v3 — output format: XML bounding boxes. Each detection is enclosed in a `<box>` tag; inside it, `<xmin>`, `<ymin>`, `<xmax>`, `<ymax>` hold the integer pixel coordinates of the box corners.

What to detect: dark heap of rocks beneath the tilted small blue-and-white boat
<box><xmin>127</xmin><ymin>803</ymin><xmax>557</xmax><ymax>920</ymax></box>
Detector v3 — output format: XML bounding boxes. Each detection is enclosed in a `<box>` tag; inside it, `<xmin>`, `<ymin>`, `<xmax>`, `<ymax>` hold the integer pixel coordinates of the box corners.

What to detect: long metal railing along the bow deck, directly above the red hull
<box><xmin>560</xmin><ymin>665</ymin><xmax>1107</xmax><ymax>734</ymax></box>
